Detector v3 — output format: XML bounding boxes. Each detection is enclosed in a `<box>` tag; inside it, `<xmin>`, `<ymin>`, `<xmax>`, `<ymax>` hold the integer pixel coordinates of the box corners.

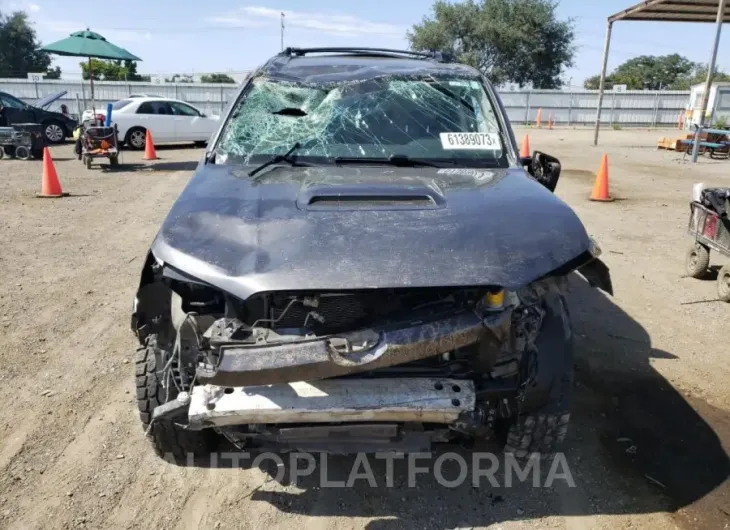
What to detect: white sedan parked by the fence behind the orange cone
<box><xmin>82</xmin><ymin>97</ymin><xmax>220</xmax><ymax>149</ymax></box>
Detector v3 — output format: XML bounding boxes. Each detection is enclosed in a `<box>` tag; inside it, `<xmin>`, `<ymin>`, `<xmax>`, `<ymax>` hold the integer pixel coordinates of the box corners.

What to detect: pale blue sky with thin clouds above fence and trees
<box><xmin>0</xmin><ymin>0</ymin><xmax>730</xmax><ymax>85</ymax></box>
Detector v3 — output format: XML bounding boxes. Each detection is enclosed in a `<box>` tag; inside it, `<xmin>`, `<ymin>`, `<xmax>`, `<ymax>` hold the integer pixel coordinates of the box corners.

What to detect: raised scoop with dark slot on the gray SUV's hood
<box><xmin>297</xmin><ymin>184</ymin><xmax>446</xmax><ymax>211</ymax></box>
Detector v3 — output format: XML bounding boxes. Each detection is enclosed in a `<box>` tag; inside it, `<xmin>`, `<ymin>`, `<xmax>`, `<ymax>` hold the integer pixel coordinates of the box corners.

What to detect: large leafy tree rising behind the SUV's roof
<box><xmin>406</xmin><ymin>0</ymin><xmax>575</xmax><ymax>88</ymax></box>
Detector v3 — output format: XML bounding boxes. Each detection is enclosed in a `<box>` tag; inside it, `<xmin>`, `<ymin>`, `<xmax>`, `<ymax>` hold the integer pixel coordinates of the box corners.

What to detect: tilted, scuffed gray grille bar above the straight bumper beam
<box><xmin>197</xmin><ymin>312</ymin><xmax>489</xmax><ymax>387</ymax></box>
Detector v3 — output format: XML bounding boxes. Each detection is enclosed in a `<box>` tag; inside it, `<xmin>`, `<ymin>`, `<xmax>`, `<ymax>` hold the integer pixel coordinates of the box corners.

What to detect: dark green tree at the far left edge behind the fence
<box><xmin>0</xmin><ymin>11</ymin><xmax>61</xmax><ymax>77</ymax></box>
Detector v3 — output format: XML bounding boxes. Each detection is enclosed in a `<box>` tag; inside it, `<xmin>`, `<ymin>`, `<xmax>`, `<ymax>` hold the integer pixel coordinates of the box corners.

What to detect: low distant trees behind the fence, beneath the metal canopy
<box><xmin>584</xmin><ymin>53</ymin><xmax>730</xmax><ymax>90</ymax></box>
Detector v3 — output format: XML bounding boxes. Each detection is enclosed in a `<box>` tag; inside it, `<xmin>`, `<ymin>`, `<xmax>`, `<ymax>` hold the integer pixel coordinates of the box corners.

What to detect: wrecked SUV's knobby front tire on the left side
<box><xmin>135</xmin><ymin>335</ymin><xmax>212</xmax><ymax>465</ymax></box>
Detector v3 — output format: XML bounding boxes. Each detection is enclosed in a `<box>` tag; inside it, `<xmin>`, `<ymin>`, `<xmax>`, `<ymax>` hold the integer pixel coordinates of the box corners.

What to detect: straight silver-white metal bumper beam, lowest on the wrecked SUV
<box><xmin>188</xmin><ymin>378</ymin><xmax>476</xmax><ymax>430</ymax></box>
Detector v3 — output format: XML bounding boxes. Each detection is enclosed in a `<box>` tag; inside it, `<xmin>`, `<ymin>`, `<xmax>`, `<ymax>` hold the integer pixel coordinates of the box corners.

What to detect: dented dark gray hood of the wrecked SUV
<box><xmin>151</xmin><ymin>164</ymin><xmax>590</xmax><ymax>299</ymax></box>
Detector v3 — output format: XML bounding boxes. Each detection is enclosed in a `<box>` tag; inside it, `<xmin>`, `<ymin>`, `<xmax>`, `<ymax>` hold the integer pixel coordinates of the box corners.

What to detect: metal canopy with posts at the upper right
<box><xmin>593</xmin><ymin>0</ymin><xmax>730</xmax><ymax>161</ymax></box>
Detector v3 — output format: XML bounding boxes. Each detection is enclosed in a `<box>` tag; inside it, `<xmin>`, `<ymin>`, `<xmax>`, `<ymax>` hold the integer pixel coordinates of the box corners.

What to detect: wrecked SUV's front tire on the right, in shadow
<box><xmin>504</xmin><ymin>290</ymin><xmax>575</xmax><ymax>459</ymax></box>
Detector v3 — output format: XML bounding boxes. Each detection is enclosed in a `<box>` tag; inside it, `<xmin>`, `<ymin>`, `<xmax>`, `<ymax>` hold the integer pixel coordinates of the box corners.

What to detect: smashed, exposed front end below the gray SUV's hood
<box><xmin>135</xmin><ymin>249</ymin><xmax>611</xmax><ymax>452</ymax></box>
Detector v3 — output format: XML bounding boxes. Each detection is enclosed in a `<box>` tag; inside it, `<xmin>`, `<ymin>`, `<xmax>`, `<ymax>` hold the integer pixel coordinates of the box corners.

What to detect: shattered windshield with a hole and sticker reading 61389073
<box><xmin>216</xmin><ymin>76</ymin><xmax>508</xmax><ymax>167</ymax></box>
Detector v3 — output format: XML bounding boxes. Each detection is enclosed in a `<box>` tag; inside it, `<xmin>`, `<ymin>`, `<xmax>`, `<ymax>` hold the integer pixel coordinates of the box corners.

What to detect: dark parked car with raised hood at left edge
<box><xmin>0</xmin><ymin>91</ymin><xmax>77</xmax><ymax>144</ymax></box>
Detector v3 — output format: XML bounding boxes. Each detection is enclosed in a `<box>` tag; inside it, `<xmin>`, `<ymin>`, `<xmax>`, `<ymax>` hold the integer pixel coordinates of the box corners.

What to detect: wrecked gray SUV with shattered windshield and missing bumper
<box><xmin>132</xmin><ymin>48</ymin><xmax>611</xmax><ymax>459</ymax></box>
